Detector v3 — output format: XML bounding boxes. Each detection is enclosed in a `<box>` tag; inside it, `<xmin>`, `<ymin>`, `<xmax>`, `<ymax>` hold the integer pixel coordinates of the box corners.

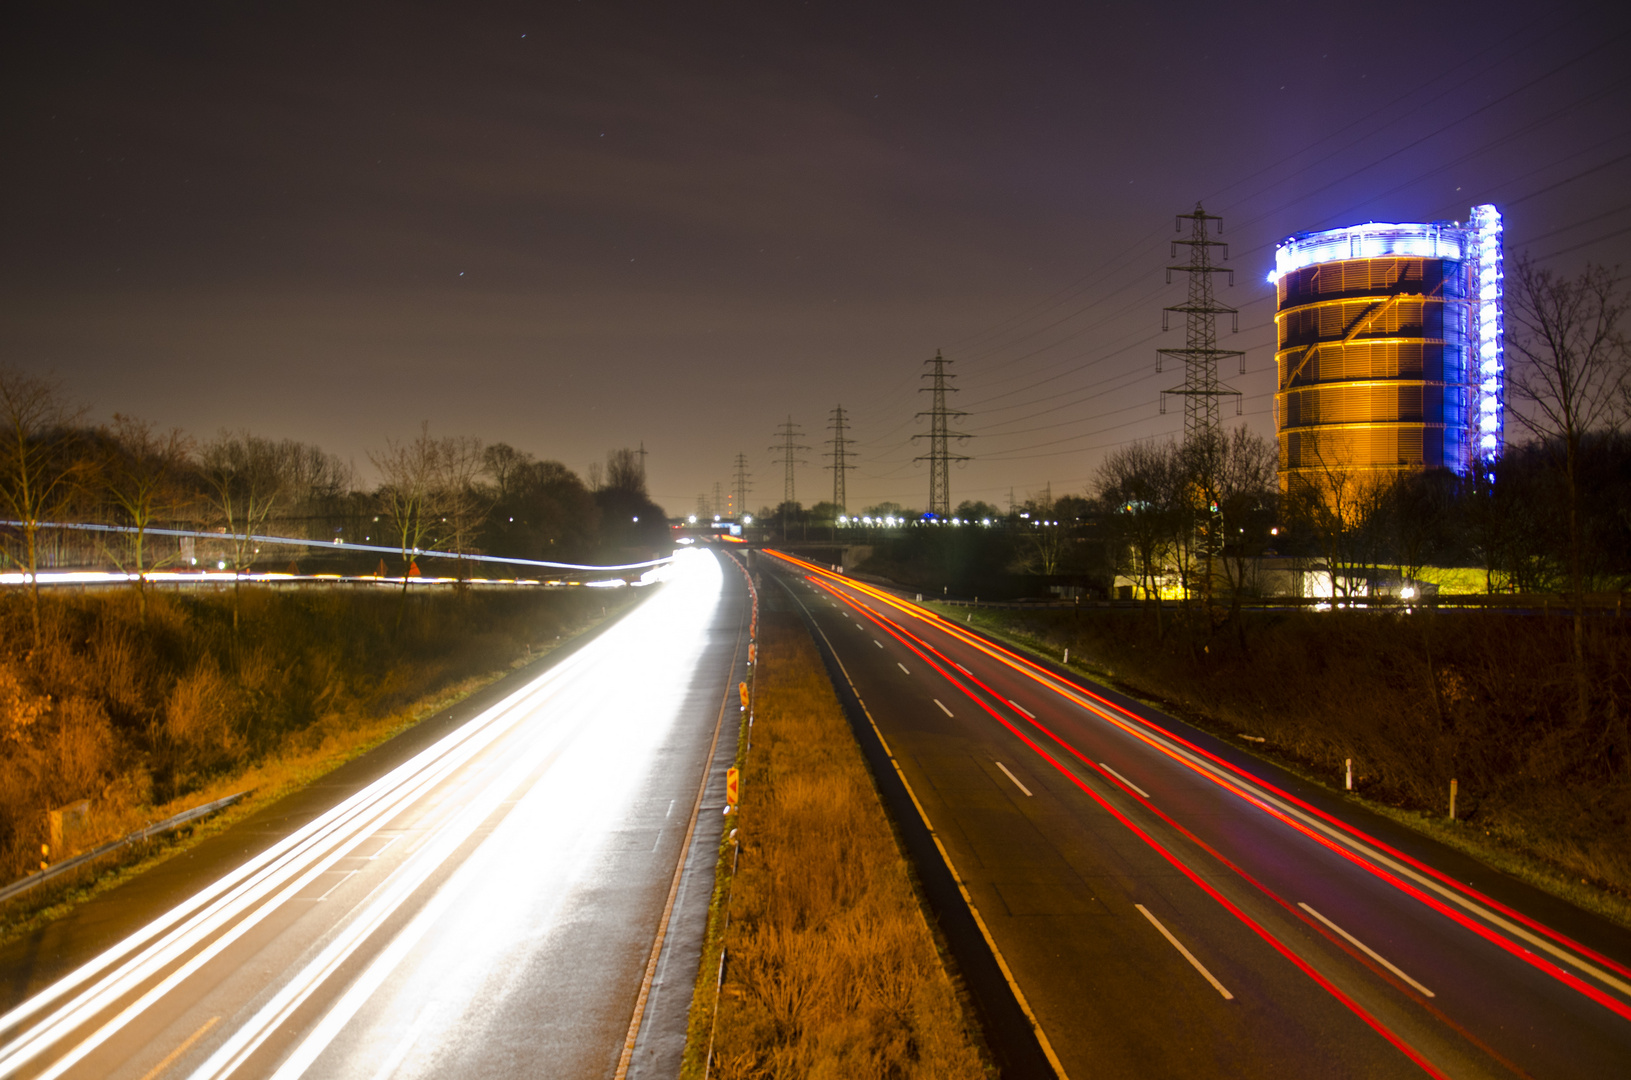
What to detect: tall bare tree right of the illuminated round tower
<box><xmin>1507</xmin><ymin>256</ymin><xmax>1631</xmax><ymax>721</ymax></box>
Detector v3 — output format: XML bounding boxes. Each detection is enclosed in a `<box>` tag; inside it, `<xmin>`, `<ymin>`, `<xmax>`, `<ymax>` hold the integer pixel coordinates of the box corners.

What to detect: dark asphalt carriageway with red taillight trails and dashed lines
<box><xmin>760</xmin><ymin>551</ymin><xmax>1631</xmax><ymax>1078</ymax></box>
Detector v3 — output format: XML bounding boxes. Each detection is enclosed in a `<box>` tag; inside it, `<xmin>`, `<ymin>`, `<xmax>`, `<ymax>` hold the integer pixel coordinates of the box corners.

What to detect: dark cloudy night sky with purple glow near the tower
<box><xmin>0</xmin><ymin>2</ymin><xmax>1631</xmax><ymax>514</ymax></box>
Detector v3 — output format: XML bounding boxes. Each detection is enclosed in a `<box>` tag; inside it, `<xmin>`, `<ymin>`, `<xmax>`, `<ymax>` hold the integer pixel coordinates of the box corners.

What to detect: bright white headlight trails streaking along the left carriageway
<box><xmin>0</xmin><ymin>551</ymin><xmax>723</xmax><ymax>1077</ymax></box>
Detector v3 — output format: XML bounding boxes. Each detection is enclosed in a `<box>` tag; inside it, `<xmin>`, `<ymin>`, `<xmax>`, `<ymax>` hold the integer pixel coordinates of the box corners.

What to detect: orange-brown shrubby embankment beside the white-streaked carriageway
<box><xmin>0</xmin><ymin>589</ymin><xmax>636</xmax><ymax>940</ymax></box>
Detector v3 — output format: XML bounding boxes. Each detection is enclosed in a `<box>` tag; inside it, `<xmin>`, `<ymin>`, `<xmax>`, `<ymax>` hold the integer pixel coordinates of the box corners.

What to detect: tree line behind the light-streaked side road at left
<box><xmin>0</xmin><ymin>369</ymin><xmax>667</xmax><ymax>646</ymax></box>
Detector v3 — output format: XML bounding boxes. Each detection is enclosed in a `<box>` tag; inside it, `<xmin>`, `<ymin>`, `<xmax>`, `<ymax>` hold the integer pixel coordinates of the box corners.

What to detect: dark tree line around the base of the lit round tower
<box><xmin>848</xmin><ymin>261</ymin><xmax>1631</xmax><ymax>618</ymax></box>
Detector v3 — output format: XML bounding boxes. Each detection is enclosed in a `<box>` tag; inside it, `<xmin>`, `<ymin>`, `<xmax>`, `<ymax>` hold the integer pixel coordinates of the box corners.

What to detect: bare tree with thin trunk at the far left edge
<box><xmin>0</xmin><ymin>369</ymin><xmax>85</xmax><ymax>649</ymax></box>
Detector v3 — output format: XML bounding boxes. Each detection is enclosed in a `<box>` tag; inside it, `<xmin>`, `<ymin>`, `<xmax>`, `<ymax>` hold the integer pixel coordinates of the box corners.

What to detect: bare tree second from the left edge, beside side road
<box><xmin>101</xmin><ymin>413</ymin><xmax>194</xmax><ymax>618</ymax></box>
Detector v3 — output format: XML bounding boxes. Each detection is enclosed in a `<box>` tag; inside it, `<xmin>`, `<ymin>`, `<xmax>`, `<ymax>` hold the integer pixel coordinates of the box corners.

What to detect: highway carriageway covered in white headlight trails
<box><xmin>0</xmin><ymin>551</ymin><xmax>752</xmax><ymax>1080</ymax></box>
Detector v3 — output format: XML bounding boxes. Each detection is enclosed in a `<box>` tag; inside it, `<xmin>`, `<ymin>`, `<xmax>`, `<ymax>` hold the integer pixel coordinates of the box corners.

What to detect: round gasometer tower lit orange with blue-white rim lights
<box><xmin>1269</xmin><ymin>206</ymin><xmax>1505</xmax><ymax>491</ymax></box>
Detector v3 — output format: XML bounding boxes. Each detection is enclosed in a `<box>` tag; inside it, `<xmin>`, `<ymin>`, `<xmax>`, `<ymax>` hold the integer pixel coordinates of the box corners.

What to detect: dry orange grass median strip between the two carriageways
<box><xmin>680</xmin><ymin>612</ymin><xmax>987</xmax><ymax>1080</ymax></box>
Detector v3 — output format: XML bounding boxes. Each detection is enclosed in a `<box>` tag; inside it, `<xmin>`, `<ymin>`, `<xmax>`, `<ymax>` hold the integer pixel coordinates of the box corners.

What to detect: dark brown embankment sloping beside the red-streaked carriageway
<box><xmin>935</xmin><ymin>605</ymin><xmax>1631</xmax><ymax>925</ymax></box>
